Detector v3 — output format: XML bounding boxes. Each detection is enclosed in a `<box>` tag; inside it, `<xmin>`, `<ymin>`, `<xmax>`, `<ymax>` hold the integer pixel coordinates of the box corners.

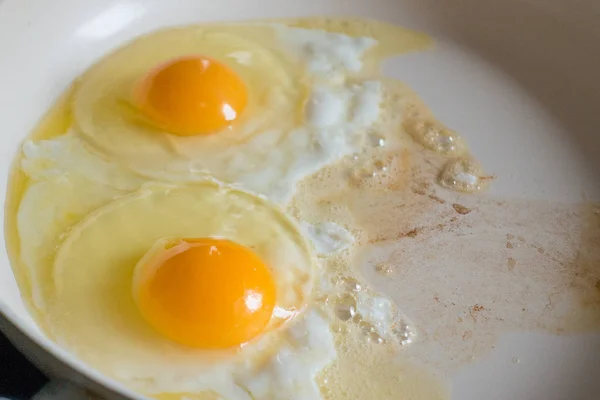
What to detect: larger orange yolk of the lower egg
<box><xmin>134</xmin><ymin>238</ymin><xmax>275</xmax><ymax>349</ymax></box>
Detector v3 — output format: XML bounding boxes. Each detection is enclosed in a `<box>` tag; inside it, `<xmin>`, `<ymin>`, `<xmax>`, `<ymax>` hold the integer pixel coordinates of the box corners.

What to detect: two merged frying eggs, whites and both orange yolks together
<box><xmin>7</xmin><ymin>19</ymin><xmax>467</xmax><ymax>400</ymax></box>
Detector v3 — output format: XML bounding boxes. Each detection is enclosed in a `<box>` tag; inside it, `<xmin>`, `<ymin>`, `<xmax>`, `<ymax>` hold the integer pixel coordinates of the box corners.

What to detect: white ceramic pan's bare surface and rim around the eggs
<box><xmin>0</xmin><ymin>0</ymin><xmax>600</xmax><ymax>400</ymax></box>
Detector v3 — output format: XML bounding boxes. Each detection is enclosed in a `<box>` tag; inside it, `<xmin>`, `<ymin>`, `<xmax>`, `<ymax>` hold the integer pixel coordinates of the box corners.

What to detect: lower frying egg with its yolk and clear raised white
<box><xmin>42</xmin><ymin>181</ymin><xmax>328</xmax><ymax>392</ymax></box>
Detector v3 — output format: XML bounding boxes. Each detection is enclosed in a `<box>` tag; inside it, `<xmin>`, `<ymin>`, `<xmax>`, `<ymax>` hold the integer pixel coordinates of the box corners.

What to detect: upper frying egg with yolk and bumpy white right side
<box><xmin>73</xmin><ymin>24</ymin><xmax>426</xmax><ymax>203</ymax></box>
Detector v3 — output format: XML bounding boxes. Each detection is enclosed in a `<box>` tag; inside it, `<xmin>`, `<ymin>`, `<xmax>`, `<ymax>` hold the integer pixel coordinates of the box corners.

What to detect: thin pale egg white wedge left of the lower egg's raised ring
<box><xmin>17</xmin><ymin>134</ymin><xmax>143</xmax><ymax>310</ymax></box>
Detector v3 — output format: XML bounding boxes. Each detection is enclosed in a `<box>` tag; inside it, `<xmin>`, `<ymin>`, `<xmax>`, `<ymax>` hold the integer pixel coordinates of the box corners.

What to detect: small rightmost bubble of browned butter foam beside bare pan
<box><xmin>438</xmin><ymin>156</ymin><xmax>484</xmax><ymax>193</ymax></box>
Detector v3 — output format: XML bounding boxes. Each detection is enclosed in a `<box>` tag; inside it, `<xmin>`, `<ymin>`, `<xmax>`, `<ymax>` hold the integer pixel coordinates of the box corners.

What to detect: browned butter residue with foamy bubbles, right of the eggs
<box><xmin>294</xmin><ymin>125</ymin><xmax>600</xmax><ymax>371</ymax></box>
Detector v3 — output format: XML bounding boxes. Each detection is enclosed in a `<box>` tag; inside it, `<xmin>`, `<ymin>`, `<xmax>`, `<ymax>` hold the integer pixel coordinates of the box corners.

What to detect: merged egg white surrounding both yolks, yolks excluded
<box><xmin>10</xmin><ymin>17</ymin><xmax>454</xmax><ymax>400</ymax></box>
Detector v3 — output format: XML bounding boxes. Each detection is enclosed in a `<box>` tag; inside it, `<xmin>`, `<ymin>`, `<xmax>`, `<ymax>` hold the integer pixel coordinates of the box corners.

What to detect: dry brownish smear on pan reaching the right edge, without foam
<box><xmin>356</xmin><ymin>196</ymin><xmax>600</xmax><ymax>371</ymax></box>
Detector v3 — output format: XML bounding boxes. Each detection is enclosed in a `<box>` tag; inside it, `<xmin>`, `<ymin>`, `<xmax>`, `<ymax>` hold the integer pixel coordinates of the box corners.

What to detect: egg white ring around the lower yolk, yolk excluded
<box><xmin>48</xmin><ymin>182</ymin><xmax>334</xmax><ymax>399</ymax></box>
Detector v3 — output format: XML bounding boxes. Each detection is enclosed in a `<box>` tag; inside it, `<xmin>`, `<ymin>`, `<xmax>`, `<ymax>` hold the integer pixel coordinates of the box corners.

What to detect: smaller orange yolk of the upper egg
<box><xmin>134</xmin><ymin>56</ymin><xmax>248</xmax><ymax>136</ymax></box>
